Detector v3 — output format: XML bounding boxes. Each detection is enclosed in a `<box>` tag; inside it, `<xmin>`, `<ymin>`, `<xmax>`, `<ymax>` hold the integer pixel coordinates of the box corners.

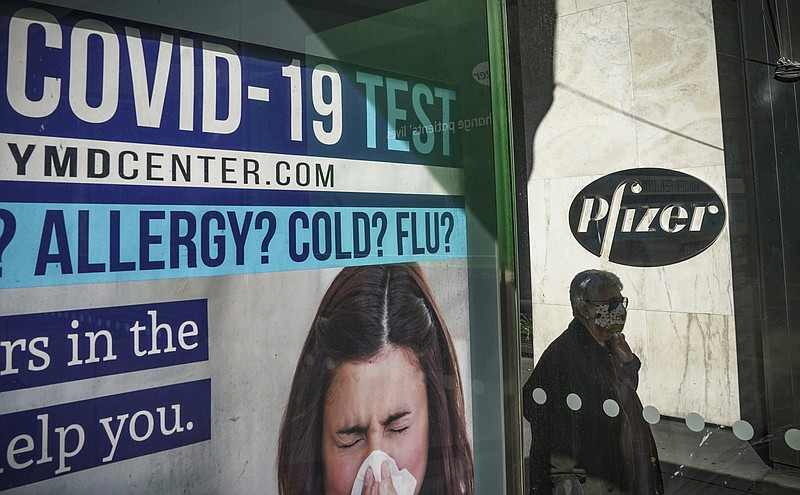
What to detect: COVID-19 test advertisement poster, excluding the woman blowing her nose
<box><xmin>0</xmin><ymin>3</ymin><xmax>470</xmax><ymax>493</ymax></box>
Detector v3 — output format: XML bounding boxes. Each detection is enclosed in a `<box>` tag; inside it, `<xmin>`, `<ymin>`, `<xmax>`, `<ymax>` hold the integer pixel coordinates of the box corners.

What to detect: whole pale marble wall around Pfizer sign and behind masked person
<box><xmin>528</xmin><ymin>0</ymin><xmax>739</xmax><ymax>424</ymax></box>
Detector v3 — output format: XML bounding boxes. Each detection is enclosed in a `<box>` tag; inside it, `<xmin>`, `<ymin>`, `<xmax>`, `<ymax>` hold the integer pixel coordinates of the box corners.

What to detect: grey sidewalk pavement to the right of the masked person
<box><xmin>651</xmin><ymin>419</ymin><xmax>800</xmax><ymax>495</ymax></box>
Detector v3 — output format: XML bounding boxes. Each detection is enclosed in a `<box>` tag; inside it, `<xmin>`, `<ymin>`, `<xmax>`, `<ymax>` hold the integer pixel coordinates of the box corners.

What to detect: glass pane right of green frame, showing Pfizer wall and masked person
<box><xmin>509</xmin><ymin>0</ymin><xmax>800</xmax><ymax>494</ymax></box>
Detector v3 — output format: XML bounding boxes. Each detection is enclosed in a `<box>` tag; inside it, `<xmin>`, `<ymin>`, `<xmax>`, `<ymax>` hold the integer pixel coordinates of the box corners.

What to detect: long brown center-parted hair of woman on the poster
<box><xmin>278</xmin><ymin>264</ymin><xmax>474</xmax><ymax>495</ymax></box>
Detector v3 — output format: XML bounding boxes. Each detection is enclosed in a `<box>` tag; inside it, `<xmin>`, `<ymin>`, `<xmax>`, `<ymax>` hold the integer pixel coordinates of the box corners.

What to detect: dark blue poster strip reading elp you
<box><xmin>0</xmin><ymin>380</ymin><xmax>211</xmax><ymax>490</ymax></box>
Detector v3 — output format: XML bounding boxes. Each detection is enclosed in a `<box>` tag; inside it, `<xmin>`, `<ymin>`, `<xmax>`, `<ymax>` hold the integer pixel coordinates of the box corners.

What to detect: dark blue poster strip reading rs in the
<box><xmin>0</xmin><ymin>300</ymin><xmax>208</xmax><ymax>391</ymax></box>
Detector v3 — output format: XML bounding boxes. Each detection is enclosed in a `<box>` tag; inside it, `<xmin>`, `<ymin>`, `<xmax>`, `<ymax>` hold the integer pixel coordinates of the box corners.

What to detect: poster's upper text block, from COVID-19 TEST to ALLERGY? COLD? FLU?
<box><xmin>0</xmin><ymin>1</ymin><xmax>466</xmax><ymax>287</ymax></box>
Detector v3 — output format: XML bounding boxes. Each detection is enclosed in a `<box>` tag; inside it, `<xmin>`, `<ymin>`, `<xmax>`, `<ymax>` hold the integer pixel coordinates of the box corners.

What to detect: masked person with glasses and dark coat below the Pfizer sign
<box><xmin>523</xmin><ymin>270</ymin><xmax>664</xmax><ymax>495</ymax></box>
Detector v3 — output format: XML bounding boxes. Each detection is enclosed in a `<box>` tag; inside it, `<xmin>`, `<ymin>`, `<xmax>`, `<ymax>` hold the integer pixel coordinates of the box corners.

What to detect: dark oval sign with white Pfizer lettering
<box><xmin>569</xmin><ymin>168</ymin><xmax>725</xmax><ymax>266</ymax></box>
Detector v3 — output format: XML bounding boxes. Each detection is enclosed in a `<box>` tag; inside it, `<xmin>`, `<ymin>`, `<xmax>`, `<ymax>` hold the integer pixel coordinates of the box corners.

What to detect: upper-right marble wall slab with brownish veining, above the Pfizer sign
<box><xmin>627</xmin><ymin>0</ymin><xmax>724</xmax><ymax>168</ymax></box>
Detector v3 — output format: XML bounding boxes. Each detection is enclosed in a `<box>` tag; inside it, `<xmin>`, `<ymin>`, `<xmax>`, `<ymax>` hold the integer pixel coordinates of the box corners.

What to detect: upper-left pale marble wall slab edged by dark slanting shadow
<box><xmin>532</xmin><ymin>3</ymin><xmax>637</xmax><ymax>178</ymax></box>
